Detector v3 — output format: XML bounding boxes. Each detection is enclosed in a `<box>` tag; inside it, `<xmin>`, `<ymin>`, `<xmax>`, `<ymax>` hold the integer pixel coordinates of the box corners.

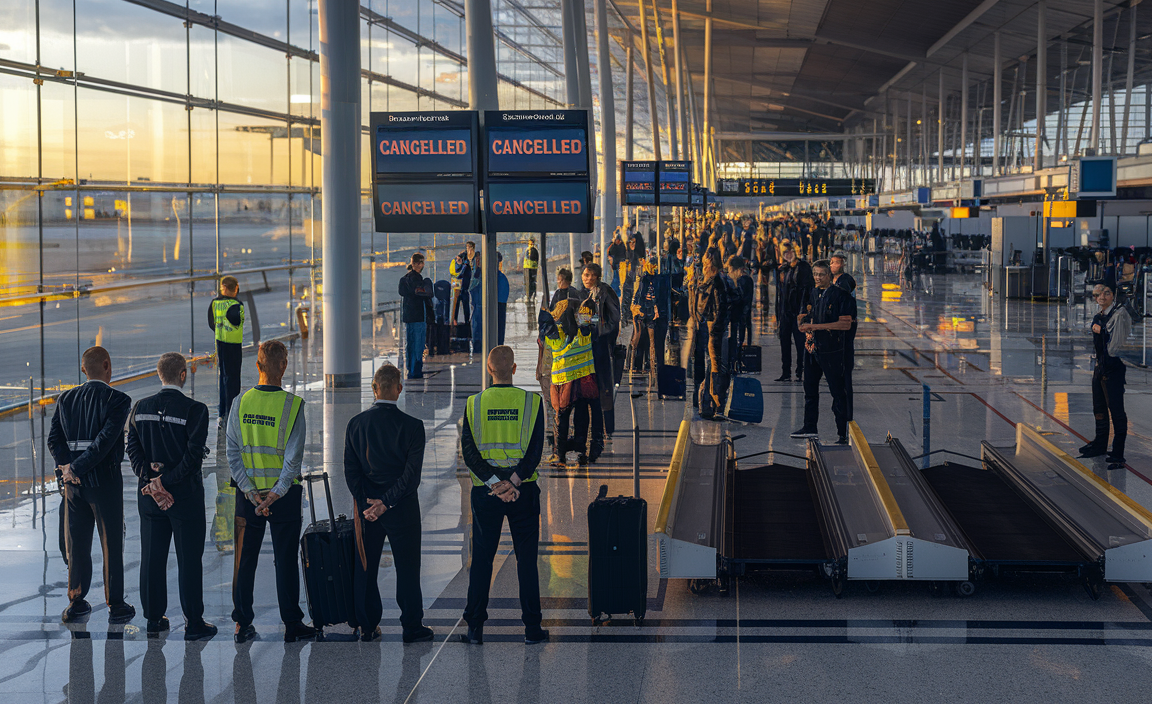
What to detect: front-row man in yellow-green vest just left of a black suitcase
<box><xmin>227</xmin><ymin>340</ymin><xmax>316</xmax><ymax>643</ymax></box>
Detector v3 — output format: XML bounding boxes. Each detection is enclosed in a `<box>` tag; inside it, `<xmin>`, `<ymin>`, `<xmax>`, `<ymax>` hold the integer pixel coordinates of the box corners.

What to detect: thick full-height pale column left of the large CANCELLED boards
<box><xmin>319</xmin><ymin>0</ymin><xmax>361</xmax><ymax>388</ymax></box>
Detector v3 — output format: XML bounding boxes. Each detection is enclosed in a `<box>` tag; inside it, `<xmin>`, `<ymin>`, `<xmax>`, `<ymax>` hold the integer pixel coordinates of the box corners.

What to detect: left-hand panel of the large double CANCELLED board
<box><xmin>371</xmin><ymin>111</ymin><xmax>480</xmax><ymax>233</ymax></box>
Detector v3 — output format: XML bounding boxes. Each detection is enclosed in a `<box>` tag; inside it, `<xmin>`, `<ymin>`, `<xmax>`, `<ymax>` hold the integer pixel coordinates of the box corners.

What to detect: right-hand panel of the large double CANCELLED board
<box><xmin>484</xmin><ymin>109</ymin><xmax>592</xmax><ymax>233</ymax></box>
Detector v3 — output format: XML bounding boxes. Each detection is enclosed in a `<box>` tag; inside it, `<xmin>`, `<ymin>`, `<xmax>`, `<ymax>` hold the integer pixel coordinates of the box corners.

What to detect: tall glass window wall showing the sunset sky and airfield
<box><xmin>0</xmin><ymin>0</ymin><xmax>667</xmax><ymax>409</ymax></box>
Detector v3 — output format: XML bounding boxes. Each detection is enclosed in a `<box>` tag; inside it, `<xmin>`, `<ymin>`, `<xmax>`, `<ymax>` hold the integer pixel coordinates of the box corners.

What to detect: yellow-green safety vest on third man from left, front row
<box><xmin>240</xmin><ymin>388</ymin><xmax>304</xmax><ymax>492</ymax></box>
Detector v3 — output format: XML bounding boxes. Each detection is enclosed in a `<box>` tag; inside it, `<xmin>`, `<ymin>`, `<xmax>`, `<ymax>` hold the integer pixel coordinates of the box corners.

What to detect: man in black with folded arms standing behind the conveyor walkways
<box><xmin>791</xmin><ymin>262</ymin><xmax>852</xmax><ymax>445</ymax></box>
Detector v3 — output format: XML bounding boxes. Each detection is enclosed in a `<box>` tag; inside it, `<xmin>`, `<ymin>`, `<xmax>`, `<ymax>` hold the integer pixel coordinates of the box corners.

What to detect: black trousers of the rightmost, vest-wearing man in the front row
<box><xmin>464</xmin><ymin>482</ymin><xmax>543</xmax><ymax>628</ymax></box>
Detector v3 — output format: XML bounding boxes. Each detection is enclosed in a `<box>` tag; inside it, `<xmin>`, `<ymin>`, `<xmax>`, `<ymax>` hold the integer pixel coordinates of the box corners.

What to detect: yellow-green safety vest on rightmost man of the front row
<box><xmin>464</xmin><ymin>386</ymin><xmax>541</xmax><ymax>486</ymax></box>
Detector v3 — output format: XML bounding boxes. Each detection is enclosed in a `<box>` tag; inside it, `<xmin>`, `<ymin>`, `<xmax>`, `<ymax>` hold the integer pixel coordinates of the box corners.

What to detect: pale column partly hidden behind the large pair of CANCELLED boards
<box><xmin>464</xmin><ymin>0</ymin><xmax>499</xmax><ymax>388</ymax></box>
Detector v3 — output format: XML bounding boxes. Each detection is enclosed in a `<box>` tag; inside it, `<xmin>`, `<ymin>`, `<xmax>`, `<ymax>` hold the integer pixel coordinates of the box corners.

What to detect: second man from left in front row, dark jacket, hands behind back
<box><xmin>128</xmin><ymin>353</ymin><xmax>217</xmax><ymax>641</ymax></box>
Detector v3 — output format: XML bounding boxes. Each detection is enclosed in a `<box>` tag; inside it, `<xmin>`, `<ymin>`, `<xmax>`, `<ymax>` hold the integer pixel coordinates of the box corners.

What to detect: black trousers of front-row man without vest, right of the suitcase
<box><xmin>353</xmin><ymin>494</ymin><xmax>424</xmax><ymax>633</ymax></box>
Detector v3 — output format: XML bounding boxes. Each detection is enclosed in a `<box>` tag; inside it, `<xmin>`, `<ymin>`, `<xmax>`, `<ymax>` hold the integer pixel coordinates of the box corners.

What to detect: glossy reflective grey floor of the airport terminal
<box><xmin>0</xmin><ymin>255</ymin><xmax>1152</xmax><ymax>703</ymax></box>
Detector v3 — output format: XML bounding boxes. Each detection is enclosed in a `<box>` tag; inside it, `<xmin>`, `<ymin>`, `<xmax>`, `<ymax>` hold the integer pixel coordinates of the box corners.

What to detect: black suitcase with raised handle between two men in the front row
<box><xmin>300</xmin><ymin>472</ymin><xmax>357</xmax><ymax>629</ymax></box>
